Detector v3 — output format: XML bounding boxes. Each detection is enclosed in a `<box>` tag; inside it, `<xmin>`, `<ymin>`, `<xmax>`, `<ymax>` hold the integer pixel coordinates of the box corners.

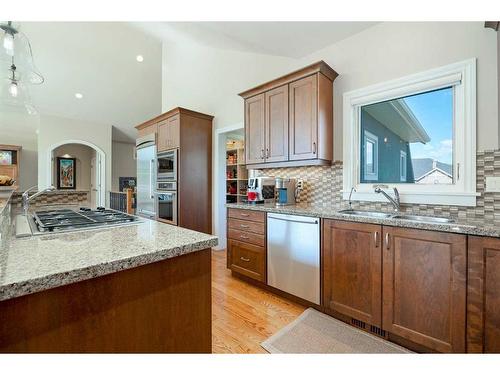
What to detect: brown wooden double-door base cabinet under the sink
<box><xmin>322</xmin><ymin>220</ymin><xmax>466</xmax><ymax>353</ymax></box>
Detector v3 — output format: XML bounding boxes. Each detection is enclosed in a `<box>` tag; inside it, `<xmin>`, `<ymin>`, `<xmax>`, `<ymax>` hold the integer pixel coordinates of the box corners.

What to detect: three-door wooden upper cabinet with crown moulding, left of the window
<box><xmin>240</xmin><ymin>61</ymin><xmax>337</xmax><ymax>168</ymax></box>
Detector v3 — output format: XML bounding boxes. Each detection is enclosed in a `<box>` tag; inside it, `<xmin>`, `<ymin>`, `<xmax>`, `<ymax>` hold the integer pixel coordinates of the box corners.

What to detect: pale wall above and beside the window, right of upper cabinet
<box><xmin>294</xmin><ymin>22</ymin><xmax>500</xmax><ymax>160</ymax></box>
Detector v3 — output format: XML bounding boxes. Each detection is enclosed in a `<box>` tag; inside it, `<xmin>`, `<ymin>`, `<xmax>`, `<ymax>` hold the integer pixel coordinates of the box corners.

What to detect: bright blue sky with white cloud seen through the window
<box><xmin>404</xmin><ymin>88</ymin><xmax>453</xmax><ymax>164</ymax></box>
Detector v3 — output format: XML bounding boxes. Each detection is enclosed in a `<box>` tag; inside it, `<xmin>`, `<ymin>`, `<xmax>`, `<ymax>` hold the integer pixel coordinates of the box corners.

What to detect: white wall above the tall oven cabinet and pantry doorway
<box><xmin>162</xmin><ymin>42</ymin><xmax>293</xmax><ymax>127</ymax></box>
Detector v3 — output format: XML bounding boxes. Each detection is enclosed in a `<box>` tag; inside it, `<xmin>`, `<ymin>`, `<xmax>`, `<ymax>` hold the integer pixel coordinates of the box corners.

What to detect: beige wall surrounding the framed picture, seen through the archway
<box><xmin>52</xmin><ymin>143</ymin><xmax>93</xmax><ymax>191</ymax></box>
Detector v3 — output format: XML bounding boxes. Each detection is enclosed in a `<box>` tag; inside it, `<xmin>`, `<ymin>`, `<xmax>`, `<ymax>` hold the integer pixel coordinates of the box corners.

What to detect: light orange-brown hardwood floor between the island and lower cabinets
<box><xmin>212</xmin><ymin>251</ymin><xmax>305</xmax><ymax>353</ymax></box>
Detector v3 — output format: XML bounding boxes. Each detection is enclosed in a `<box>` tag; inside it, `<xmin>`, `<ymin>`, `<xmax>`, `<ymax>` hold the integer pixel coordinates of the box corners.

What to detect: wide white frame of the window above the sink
<box><xmin>343</xmin><ymin>58</ymin><xmax>479</xmax><ymax>206</ymax></box>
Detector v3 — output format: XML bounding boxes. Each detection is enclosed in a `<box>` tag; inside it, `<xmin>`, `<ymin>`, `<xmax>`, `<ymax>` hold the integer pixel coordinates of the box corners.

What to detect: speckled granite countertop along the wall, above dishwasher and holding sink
<box><xmin>226</xmin><ymin>203</ymin><xmax>500</xmax><ymax>237</ymax></box>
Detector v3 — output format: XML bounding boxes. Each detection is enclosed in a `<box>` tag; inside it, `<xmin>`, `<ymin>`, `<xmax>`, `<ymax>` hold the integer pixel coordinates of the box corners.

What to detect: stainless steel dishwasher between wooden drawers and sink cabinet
<box><xmin>267</xmin><ymin>213</ymin><xmax>320</xmax><ymax>305</ymax></box>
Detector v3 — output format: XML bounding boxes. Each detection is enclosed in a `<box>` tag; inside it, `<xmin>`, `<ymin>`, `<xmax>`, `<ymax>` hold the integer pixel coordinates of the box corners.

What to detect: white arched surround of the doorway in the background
<box><xmin>46</xmin><ymin>139</ymin><xmax>106</xmax><ymax>206</ymax></box>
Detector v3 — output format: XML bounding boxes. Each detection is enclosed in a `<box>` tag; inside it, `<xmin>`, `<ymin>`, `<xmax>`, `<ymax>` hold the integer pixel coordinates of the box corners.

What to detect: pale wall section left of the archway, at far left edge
<box><xmin>0</xmin><ymin>112</ymin><xmax>39</xmax><ymax>190</ymax></box>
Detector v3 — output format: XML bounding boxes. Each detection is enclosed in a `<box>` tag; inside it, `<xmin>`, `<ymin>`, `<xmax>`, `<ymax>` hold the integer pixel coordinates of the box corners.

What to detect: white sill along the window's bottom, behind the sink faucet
<box><xmin>342</xmin><ymin>190</ymin><xmax>481</xmax><ymax>207</ymax></box>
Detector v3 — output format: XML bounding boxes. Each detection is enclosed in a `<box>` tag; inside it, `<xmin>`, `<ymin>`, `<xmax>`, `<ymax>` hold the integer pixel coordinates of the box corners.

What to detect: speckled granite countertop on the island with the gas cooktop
<box><xmin>0</xmin><ymin>212</ymin><xmax>217</xmax><ymax>301</ymax></box>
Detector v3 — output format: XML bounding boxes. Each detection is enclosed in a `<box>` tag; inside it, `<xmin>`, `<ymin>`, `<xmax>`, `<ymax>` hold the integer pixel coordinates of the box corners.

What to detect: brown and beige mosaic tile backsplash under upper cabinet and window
<box><xmin>258</xmin><ymin>150</ymin><xmax>500</xmax><ymax>223</ymax></box>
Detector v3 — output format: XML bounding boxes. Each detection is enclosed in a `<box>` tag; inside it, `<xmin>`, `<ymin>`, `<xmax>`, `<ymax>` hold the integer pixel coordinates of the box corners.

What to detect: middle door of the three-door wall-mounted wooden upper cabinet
<box><xmin>265</xmin><ymin>85</ymin><xmax>288</xmax><ymax>162</ymax></box>
